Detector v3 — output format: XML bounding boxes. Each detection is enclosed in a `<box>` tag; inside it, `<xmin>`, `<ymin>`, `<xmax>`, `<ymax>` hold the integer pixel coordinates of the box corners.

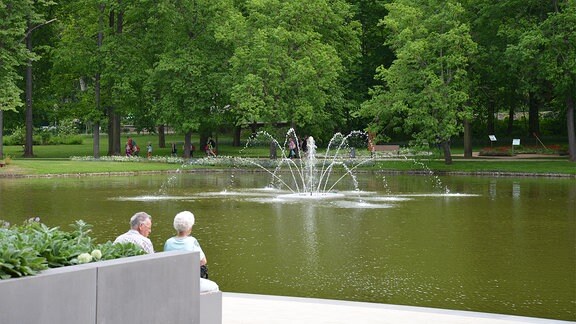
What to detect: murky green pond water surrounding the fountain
<box><xmin>0</xmin><ymin>172</ymin><xmax>576</xmax><ymax>321</ymax></box>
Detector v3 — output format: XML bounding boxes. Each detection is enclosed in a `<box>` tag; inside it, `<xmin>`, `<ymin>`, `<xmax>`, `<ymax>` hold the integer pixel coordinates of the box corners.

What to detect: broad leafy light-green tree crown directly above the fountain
<box><xmin>226</xmin><ymin>0</ymin><xmax>360</xmax><ymax>140</ymax></box>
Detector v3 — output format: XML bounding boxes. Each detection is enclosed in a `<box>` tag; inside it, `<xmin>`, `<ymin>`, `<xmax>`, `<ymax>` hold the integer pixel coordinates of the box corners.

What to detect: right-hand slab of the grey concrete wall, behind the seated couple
<box><xmin>97</xmin><ymin>252</ymin><xmax>200</xmax><ymax>324</ymax></box>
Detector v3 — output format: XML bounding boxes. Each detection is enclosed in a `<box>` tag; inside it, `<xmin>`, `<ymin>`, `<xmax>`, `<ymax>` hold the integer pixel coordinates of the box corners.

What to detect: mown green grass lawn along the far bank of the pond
<box><xmin>0</xmin><ymin>135</ymin><xmax>576</xmax><ymax>176</ymax></box>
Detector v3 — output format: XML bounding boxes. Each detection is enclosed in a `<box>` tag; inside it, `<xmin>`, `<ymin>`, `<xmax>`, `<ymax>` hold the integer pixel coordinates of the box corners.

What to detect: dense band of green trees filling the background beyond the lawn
<box><xmin>0</xmin><ymin>0</ymin><xmax>576</xmax><ymax>163</ymax></box>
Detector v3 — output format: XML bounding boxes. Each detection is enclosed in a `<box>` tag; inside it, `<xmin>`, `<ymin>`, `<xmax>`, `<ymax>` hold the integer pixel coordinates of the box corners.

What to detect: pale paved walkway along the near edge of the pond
<box><xmin>222</xmin><ymin>293</ymin><xmax>574</xmax><ymax>324</ymax></box>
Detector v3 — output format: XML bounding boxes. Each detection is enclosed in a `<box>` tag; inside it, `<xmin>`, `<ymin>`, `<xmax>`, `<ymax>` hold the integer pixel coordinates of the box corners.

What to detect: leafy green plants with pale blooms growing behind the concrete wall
<box><xmin>0</xmin><ymin>219</ymin><xmax>144</xmax><ymax>279</ymax></box>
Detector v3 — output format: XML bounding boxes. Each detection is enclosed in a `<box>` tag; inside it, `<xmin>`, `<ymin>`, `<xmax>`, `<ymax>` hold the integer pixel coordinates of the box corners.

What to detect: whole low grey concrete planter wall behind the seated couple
<box><xmin>0</xmin><ymin>252</ymin><xmax>205</xmax><ymax>324</ymax></box>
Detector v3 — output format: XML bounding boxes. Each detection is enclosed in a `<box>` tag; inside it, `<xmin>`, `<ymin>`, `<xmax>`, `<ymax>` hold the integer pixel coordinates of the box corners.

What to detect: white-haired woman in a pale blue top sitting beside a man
<box><xmin>164</xmin><ymin>211</ymin><xmax>219</xmax><ymax>292</ymax></box>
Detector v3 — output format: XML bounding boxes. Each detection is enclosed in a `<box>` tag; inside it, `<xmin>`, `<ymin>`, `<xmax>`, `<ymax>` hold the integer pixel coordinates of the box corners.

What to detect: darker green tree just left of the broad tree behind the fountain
<box><xmin>145</xmin><ymin>0</ymin><xmax>237</xmax><ymax>157</ymax></box>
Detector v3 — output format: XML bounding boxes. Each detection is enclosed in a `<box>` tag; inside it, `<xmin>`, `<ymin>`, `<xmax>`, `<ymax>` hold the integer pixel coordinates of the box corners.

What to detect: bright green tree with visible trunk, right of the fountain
<box><xmin>362</xmin><ymin>0</ymin><xmax>476</xmax><ymax>164</ymax></box>
